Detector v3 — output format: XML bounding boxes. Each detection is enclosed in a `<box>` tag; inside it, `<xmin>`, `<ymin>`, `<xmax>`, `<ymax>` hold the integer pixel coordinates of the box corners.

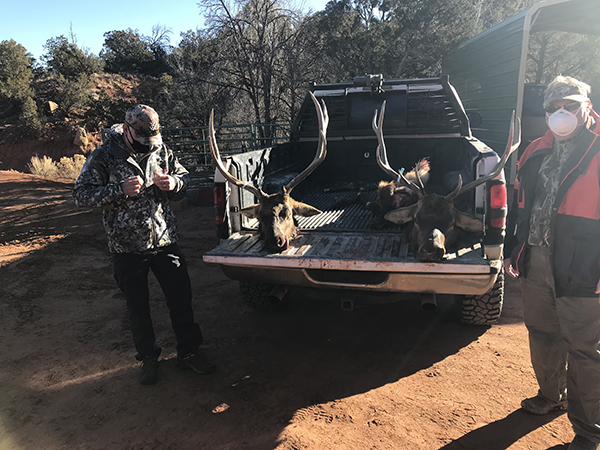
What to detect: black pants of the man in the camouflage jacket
<box><xmin>113</xmin><ymin>244</ymin><xmax>202</xmax><ymax>359</ymax></box>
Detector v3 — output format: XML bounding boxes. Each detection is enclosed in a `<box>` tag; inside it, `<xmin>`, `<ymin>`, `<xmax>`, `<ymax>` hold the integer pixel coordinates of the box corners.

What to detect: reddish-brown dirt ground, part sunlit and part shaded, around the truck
<box><xmin>0</xmin><ymin>171</ymin><xmax>573</xmax><ymax>450</ymax></box>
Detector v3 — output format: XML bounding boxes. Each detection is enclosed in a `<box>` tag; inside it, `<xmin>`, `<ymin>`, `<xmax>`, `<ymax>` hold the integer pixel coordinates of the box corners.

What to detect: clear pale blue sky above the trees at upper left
<box><xmin>0</xmin><ymin>0</ymin><xmax>327</xmax><ymax>62</ymax></box>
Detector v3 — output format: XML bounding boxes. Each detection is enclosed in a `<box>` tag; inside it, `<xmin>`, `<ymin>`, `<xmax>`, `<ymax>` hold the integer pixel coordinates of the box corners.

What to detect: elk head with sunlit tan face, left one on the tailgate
<box><xmin>208</xmin><ymin>92</ymin><xmax>329</xmax><ymax>253</ymax></box>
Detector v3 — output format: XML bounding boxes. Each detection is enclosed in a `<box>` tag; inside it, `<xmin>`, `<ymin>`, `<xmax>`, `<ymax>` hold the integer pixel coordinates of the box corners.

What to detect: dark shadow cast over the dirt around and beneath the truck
<box><xmin>0</xmin><ymin>178</ymin><xmax>545</xmax><ymax>450</ymax></box>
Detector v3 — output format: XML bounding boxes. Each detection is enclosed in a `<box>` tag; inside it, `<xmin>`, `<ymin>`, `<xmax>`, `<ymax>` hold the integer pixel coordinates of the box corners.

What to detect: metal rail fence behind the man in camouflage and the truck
<box><xmin>101</xmin><ymin>123</ymin><xmax>290</xmax><ymax>188</ymax></box>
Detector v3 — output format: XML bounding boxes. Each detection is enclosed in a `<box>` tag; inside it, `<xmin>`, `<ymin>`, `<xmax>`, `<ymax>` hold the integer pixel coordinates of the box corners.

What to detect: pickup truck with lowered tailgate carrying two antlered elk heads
<box><xmin>204</xmin><ymin>75</ymin><xmax>507</xmax><ymax>325</ymax></box>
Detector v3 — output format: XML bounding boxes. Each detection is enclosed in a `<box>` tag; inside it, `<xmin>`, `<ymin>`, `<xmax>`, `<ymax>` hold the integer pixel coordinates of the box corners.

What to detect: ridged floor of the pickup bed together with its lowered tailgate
<box><xmin>204</xmin><ymin>190</ymin><xmax>490</xmax><ymax>273</ymax></box>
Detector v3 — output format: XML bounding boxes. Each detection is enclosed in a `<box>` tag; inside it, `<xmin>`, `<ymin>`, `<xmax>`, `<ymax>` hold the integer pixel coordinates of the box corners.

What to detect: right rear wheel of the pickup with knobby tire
<box><xmin>458</xmin><ymin>268</ymin><xmax>504</xmax><ymax>325</ymax></box>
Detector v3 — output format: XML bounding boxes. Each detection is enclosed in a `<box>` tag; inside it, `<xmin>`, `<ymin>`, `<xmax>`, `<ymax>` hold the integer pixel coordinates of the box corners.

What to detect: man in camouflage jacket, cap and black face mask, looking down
<box><xmin>73</xmin><ymin>105</ymin><xmax>214</xmax><ymax>384</ymax></box>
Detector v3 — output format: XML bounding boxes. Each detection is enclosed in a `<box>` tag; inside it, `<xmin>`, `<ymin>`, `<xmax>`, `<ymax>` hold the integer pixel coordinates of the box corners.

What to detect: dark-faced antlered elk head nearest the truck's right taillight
<box><xmin>373</xmin><ymin>101</ymin><xmax>521</xmax><ymax>261</ymax></box>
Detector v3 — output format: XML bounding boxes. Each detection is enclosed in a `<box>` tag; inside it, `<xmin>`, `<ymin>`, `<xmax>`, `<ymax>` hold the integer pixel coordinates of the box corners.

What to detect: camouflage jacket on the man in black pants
<box><xmin>73</xmin><ymin>125</ymin><xmax>189</xmax><ymax>253</ymax></box>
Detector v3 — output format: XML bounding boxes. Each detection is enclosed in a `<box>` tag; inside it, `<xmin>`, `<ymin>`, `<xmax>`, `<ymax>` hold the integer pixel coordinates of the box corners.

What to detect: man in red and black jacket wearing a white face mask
<box><xmin>505</xmin><ymin>76</ymin><xmax>600</xmax><ymax>450</ymax></box>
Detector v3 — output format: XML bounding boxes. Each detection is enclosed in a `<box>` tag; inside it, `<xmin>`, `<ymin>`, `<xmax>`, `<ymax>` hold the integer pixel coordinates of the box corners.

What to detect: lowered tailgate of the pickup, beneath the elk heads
<box><xmin>204</xmin><ymin>231</ymin><xmax>490</xmax><ymax>275</ymax></box>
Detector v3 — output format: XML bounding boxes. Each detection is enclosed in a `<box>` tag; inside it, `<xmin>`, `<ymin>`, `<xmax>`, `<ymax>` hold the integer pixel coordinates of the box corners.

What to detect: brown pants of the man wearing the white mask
<box><xmin>521</xmin><ymin>247</ymin><xmax>600</xmax><ymax>442</ymax></box>
